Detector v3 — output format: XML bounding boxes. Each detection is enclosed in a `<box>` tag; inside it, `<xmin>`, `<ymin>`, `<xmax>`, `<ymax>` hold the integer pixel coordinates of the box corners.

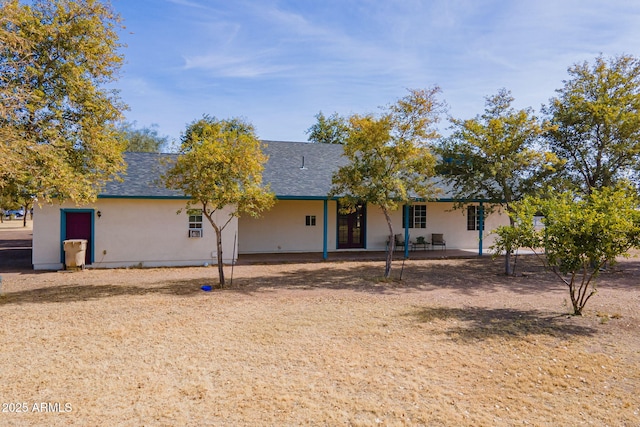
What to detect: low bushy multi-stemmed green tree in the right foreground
<box><xmin>494</xmin><ymin>186</ymin><xmax>640</xmax><ymax>315</ymax></box>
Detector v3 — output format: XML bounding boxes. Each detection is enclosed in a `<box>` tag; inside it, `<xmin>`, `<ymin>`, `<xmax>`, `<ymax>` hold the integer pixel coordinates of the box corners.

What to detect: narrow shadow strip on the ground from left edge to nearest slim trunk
<box><xmin>0</xmin><ymin>279</ymin><xmax>205</xmax><ymax>306</ymax></box>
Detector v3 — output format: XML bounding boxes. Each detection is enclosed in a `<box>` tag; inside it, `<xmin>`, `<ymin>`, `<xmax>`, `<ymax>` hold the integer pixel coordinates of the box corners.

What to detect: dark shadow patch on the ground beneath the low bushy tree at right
<box><xmin>408</xmin><ymin>307</ymin><xmax>597</xmax><ymax>342</ymax></box>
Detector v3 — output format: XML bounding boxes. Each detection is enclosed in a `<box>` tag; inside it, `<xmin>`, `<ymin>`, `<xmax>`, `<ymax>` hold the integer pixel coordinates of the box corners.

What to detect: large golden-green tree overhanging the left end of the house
<box><xmin>0</xmin><ymin>0</ymin><xmax>124</xmax><ymax>203</ymax></box>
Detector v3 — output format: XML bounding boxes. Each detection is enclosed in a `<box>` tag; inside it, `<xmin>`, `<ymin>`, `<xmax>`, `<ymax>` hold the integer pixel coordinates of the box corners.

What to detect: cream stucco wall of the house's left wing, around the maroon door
<box><xmin>33</xmin><ymin>199</ymin><xmax>237</xmax><ymax>270</ymax></box>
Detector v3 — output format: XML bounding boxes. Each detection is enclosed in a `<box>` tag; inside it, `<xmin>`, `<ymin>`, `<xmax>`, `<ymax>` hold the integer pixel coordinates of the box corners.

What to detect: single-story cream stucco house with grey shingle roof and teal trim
<box><xmin>33</xmin><ymin>141</ymin><xmax>508</xmax><ymax>270</ymax></box>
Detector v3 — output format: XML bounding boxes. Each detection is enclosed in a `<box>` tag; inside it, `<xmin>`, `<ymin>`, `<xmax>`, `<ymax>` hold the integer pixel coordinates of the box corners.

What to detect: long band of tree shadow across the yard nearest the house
<box><xmin>0</xmin><ymin>257</ymin><xmax>640</xmax><ymax>305</ymax></box>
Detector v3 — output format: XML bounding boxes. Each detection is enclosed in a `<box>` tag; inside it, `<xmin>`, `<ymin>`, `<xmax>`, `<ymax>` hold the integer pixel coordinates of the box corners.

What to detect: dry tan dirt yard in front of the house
<box><xmin>0</xmin><ymin>237</ymin><xmax>640</xmax><ymax>426</ymax></box>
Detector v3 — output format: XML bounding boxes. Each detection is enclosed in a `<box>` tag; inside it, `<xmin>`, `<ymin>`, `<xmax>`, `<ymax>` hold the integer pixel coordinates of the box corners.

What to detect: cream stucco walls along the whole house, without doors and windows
<box><xmin>33</xmin><ymin>199</ymin><xmax>508</xmax><ymax>270</ymax></box>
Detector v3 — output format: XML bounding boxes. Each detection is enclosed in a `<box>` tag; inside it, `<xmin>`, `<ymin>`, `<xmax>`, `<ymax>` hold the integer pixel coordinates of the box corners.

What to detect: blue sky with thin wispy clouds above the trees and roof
<box><xmin>111</xmin><ymin>0</ymin><xmax>640</xmax><ymax>142</ymax></box>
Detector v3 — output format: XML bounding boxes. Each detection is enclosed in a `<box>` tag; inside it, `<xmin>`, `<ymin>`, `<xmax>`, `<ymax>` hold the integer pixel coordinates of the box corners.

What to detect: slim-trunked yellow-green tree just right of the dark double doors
<box><xmin>330</xmin><ymin>87</ymin><xmax>443</xmax><ymax>278</ymax></box>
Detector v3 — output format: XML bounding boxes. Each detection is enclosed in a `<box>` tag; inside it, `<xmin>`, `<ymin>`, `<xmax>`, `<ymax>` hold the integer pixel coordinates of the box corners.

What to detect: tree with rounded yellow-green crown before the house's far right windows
<box><xmin>437</xmin><ymin>89</ymin><xmax>559</xmax><ymax>274</ymax></box>
